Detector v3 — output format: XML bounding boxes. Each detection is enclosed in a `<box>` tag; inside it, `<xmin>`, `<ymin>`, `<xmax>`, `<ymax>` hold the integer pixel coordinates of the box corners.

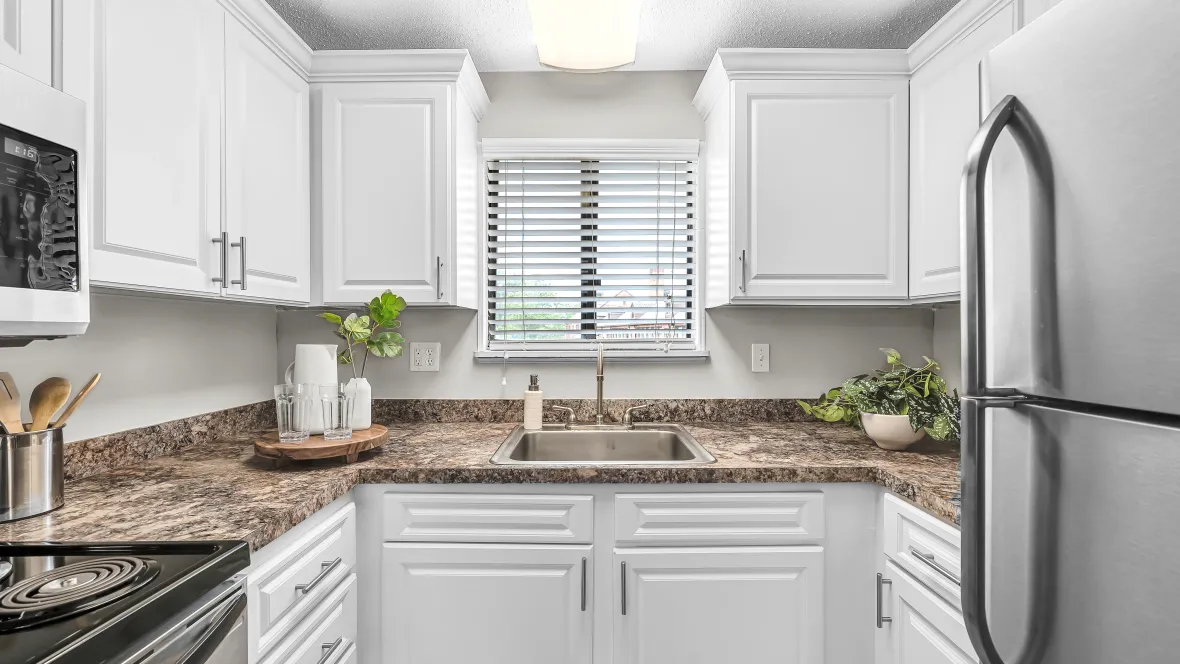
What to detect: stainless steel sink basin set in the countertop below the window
<box><xmin>492</xmin><ymin>423</ymin><xmax>716</xmax><ymax>466</ymax></box>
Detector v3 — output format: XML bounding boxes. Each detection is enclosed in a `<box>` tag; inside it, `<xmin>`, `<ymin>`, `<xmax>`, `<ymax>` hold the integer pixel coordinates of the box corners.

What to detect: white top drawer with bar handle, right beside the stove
<box><xmin>248</xmin><ymin>502</ymin><xmax>356</xmax><ymax>655</ymax></box>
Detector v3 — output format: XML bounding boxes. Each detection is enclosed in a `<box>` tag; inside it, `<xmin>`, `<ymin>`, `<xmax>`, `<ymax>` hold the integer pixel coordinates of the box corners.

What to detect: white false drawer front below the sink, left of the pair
<box><xmin>382</xmin><ymin>493</ymin><xmax>594</xmax><ymax>544</ymax></box>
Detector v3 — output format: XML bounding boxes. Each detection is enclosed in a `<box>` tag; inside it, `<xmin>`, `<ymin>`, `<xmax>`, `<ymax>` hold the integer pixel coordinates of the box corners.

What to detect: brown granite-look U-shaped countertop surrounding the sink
<box><xmin>0</xmin><ymin>422</ymin><xmax>959</xmax><ymax>550</ymax></box>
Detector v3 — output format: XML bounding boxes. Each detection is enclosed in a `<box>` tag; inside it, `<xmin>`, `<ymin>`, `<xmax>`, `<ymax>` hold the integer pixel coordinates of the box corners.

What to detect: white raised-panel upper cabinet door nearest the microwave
<box><xmin>90</xmin><ymin>0</ymin><xmax>224</xmax><ymax>294</ymax></box>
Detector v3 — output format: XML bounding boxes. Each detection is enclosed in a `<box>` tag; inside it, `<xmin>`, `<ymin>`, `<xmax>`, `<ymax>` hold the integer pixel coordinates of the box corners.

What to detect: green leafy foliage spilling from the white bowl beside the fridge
<box><xmin>799</xmin><ymin>348</ymin><xmax>959</xmax><ymax>440</ymax></box>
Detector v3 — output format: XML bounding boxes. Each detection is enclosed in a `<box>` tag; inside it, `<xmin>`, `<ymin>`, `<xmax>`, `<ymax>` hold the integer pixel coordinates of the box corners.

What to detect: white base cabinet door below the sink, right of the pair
<box><xmin>612</xmin><ymin>546</ymin><xmax>824</xmax><ymax>664</ymax></box>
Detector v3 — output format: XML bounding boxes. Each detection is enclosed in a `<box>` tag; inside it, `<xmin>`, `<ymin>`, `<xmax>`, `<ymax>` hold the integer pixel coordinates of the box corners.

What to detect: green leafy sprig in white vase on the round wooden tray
<box><xmin>320</xmin><ymin>290</ymin><xmax>406</xmax><ymax>429</ymax></box>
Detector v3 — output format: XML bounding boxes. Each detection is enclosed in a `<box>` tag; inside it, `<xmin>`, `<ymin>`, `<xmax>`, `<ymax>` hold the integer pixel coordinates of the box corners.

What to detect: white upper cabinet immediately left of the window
<box><xmin>313</xmin><ymin>51</ymin><xmax>487</xmax><ymax>308</ymax></box>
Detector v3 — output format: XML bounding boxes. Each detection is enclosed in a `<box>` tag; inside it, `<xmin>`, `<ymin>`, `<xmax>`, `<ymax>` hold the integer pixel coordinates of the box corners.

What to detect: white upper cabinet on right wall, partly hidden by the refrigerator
<box><xmin>910</xmin><ymin>5</ymin><xmax>1017</xmax><ymax>297</ymax></box>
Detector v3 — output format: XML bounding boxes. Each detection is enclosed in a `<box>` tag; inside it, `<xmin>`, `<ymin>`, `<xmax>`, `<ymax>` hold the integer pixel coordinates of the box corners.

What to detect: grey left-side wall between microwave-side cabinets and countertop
<box><xmin>0</xmin><ymin>294</ymin><xmax>277</xmax><ymax>441</ymax></box>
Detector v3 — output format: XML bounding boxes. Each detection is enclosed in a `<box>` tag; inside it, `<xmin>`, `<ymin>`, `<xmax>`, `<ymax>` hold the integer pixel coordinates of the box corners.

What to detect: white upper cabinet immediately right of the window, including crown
<box><xmin>695</xmin><ymin>48</ymin><xmax>909</xmax><ymax>307</ymax></box>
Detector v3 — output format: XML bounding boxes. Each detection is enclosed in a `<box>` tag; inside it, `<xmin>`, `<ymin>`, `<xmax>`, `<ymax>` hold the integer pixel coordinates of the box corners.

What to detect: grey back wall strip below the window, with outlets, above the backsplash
<box><xmin>276</xmin><ymin>307</ymin><xmax>933</xmax><ymax>399</ymax></box>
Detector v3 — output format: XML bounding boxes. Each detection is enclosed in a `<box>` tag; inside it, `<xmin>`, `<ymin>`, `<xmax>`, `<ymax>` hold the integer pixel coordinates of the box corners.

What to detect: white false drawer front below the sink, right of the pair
<box><xmin>615</xmin><ymin>492</ymin><xmax>824</xmax><ymax>546</ymax></box>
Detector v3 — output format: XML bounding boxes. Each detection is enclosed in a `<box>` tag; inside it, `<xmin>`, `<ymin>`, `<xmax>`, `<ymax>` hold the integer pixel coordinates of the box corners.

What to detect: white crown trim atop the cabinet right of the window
<box><xmin>693</xmin><ymin>48</ymin><xmax>910</xmax><ymax>117</ymax></box>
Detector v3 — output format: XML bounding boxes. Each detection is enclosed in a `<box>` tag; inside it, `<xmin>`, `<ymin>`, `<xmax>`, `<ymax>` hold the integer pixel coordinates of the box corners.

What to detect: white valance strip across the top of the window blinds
<box><xmin>479</xmin><ymin>138</ymin><xmax>701</xmax><ymax>159</ymax></box>
